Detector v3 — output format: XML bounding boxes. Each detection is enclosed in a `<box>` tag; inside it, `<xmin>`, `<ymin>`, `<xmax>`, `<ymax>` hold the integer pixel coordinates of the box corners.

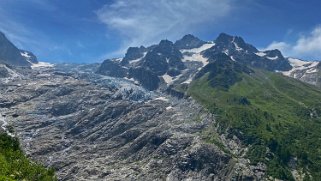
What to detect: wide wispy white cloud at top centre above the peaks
<box><xmin>96</xmin><ymin>0</ymin><xmax>232</xmax><ymax>53</ymax></box>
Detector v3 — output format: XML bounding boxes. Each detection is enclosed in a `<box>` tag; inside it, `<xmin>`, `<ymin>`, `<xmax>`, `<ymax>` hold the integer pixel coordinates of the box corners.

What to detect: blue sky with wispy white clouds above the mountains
<box><xmin>0</xmin><ymin>0</ymin><xmax>321</xmax><ymax>63</ymax></box>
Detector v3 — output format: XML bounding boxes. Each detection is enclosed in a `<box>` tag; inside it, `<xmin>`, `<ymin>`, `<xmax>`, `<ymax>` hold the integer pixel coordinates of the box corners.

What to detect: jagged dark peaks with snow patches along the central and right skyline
<box><xmin>97</xmin><ymin>33</ymin><xmax>320</xmax><ymax>91</ymax></box>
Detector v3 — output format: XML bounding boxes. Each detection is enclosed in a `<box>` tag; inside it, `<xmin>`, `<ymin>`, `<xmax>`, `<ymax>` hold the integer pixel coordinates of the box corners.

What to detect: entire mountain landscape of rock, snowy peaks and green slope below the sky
<box><xmin>0</xmin><ymin>33</ymin><xmax>321</xmax><ymax>181</ymax></box>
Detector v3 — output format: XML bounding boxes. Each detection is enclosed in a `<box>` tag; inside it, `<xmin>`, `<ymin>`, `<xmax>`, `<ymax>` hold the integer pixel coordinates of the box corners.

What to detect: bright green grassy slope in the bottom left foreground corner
<box><xmin>0</xmin><ymin>133</ymin><xmax>56</xmax><ymax>181</ymax></box>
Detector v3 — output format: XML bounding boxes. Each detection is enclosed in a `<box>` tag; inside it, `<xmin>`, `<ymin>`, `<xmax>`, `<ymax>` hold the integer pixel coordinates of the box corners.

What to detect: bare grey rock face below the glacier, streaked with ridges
<box><xmin>0</xmin><ymin>65</ymin><xmax>264</xmax><ymax>181</ymax></box>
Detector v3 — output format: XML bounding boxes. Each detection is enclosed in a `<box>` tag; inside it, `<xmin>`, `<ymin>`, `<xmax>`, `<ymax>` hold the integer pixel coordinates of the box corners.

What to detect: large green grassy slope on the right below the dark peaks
<box><xmin>188</xmin><ymin>70</ymin><xmax>321</xmax><ymax>180</ymax></box>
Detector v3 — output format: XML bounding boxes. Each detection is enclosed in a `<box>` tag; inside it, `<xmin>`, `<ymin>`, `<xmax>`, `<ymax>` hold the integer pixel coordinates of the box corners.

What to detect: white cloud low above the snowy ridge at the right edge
<box><xmin>266</xmin><ymin>26</ymin><xmax>321</xmax><ymax>60</ymax></box>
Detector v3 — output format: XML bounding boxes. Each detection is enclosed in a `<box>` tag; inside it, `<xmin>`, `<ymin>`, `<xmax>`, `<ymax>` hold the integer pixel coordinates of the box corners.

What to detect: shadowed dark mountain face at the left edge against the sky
<box><xmin>0</xmin><ymin>32</ymin><xmax>36</xmax><ymax>66</ymax></box>
